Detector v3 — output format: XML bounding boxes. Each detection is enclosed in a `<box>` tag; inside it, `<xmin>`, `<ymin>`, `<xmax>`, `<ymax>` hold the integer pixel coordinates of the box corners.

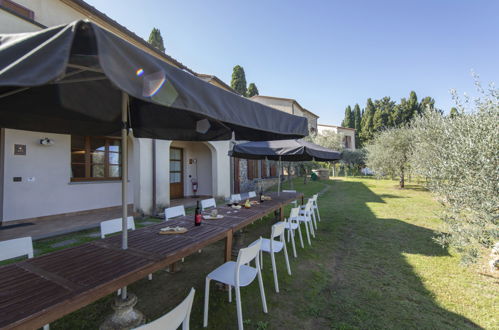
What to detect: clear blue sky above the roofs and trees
<box><xmin>87</xmin><ymin>0</ymin><xmax>499</xmax><ymax>124</ymax></box>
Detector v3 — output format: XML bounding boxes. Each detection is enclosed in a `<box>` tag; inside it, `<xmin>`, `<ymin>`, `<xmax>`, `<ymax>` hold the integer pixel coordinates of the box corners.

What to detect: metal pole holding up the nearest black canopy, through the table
<box><xmin>121</xmin><ymin>92</ymin><xmax>128</xmax><ymax>299</ymax></box>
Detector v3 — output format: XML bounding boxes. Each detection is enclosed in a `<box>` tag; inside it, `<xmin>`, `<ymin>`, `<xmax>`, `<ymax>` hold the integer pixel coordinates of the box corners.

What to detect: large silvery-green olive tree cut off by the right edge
<box><xmin>411</xmin><ymin>83</ymin><xmax>499</xmax><ymax>262</ymax></box>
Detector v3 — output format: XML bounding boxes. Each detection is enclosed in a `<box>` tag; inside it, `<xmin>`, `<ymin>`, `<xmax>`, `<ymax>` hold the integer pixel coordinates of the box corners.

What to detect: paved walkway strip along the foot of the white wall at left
<box><xmin>0</xmin><ymin>207</ymin><xmax>132</xmax><ymax>241</ymax></box>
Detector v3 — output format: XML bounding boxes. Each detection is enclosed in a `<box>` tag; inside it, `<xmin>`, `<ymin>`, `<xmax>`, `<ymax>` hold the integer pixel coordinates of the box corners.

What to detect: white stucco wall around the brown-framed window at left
<box><xmin>2</xmin><ymin>129</ymin><xmax>133</xmax><ymax>221</ymax></box>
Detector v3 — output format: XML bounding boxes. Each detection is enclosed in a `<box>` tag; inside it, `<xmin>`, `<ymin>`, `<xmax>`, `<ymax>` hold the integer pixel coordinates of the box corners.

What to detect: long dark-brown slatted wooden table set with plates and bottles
<box><xmin>0</xmin><ymin>193</ymin><xmax>303</xmax><ymax>329</ymax></box>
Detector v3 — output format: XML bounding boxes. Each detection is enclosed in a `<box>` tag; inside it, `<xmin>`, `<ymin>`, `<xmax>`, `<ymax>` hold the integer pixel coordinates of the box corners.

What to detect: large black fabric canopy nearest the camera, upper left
<box><xmin>0</xmin><ymin>21</ymin><xmax>308</xmax><ymax>141</ymax></box>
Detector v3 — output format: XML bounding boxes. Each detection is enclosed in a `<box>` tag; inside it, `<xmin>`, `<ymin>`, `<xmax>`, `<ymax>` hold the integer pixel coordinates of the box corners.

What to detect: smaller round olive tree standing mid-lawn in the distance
<box><xmin>365</xmin><ymin>127</ymin><xmax>412</xmax><ymax>188</ymax></box>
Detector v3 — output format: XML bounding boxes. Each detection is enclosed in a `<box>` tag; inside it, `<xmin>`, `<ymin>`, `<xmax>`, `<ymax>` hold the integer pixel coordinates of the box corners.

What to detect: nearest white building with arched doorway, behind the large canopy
<box><xmin>0</xmin><ymin>0</ymin><xmax>231</xmax><ymax>222</ymax></box>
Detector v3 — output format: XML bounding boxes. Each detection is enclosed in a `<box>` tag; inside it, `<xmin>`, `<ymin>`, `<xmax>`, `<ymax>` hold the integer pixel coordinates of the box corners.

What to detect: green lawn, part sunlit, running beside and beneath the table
<box><xmin>4</xmin><ymin>178</ymin><xmax>499</xmax><ymax>329</ymax></box>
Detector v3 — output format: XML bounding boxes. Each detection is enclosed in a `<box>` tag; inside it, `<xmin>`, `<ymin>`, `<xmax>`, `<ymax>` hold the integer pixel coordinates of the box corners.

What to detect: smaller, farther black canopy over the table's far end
<box><xmin>229</xmin><ymin>140</ymin><xmax>341</xmax><ymax>162</ymax></box>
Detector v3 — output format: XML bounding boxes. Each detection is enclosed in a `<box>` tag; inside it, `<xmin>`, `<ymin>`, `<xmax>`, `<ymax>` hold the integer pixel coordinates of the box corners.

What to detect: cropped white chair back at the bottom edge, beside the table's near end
<box><xmin>136</xmin><ymin>288</ymin><xmax>196</xmax><ymax>330</ymax></box>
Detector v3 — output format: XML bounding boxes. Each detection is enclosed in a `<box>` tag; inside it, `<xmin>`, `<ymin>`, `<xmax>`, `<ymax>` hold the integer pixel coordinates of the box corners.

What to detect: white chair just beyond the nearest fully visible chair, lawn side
<box><xmin>253</xmin><ymin>222</ymin><xmax>291</xmax><ymax>293</ymax></box>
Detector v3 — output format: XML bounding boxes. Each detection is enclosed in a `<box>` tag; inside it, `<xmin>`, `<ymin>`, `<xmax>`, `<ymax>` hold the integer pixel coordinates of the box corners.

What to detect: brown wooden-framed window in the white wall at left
<box><xmin>71</xmin><ymin>136</ymin><xmax>121</xmax><ymax>181</ymax></box>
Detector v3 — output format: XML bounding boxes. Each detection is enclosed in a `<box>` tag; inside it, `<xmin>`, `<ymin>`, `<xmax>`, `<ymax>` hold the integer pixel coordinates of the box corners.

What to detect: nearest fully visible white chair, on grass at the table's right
<box><xmin>203</xmin><ymin>238</ymin><xmax>267</xmax><ymax>330</ymax></box>
